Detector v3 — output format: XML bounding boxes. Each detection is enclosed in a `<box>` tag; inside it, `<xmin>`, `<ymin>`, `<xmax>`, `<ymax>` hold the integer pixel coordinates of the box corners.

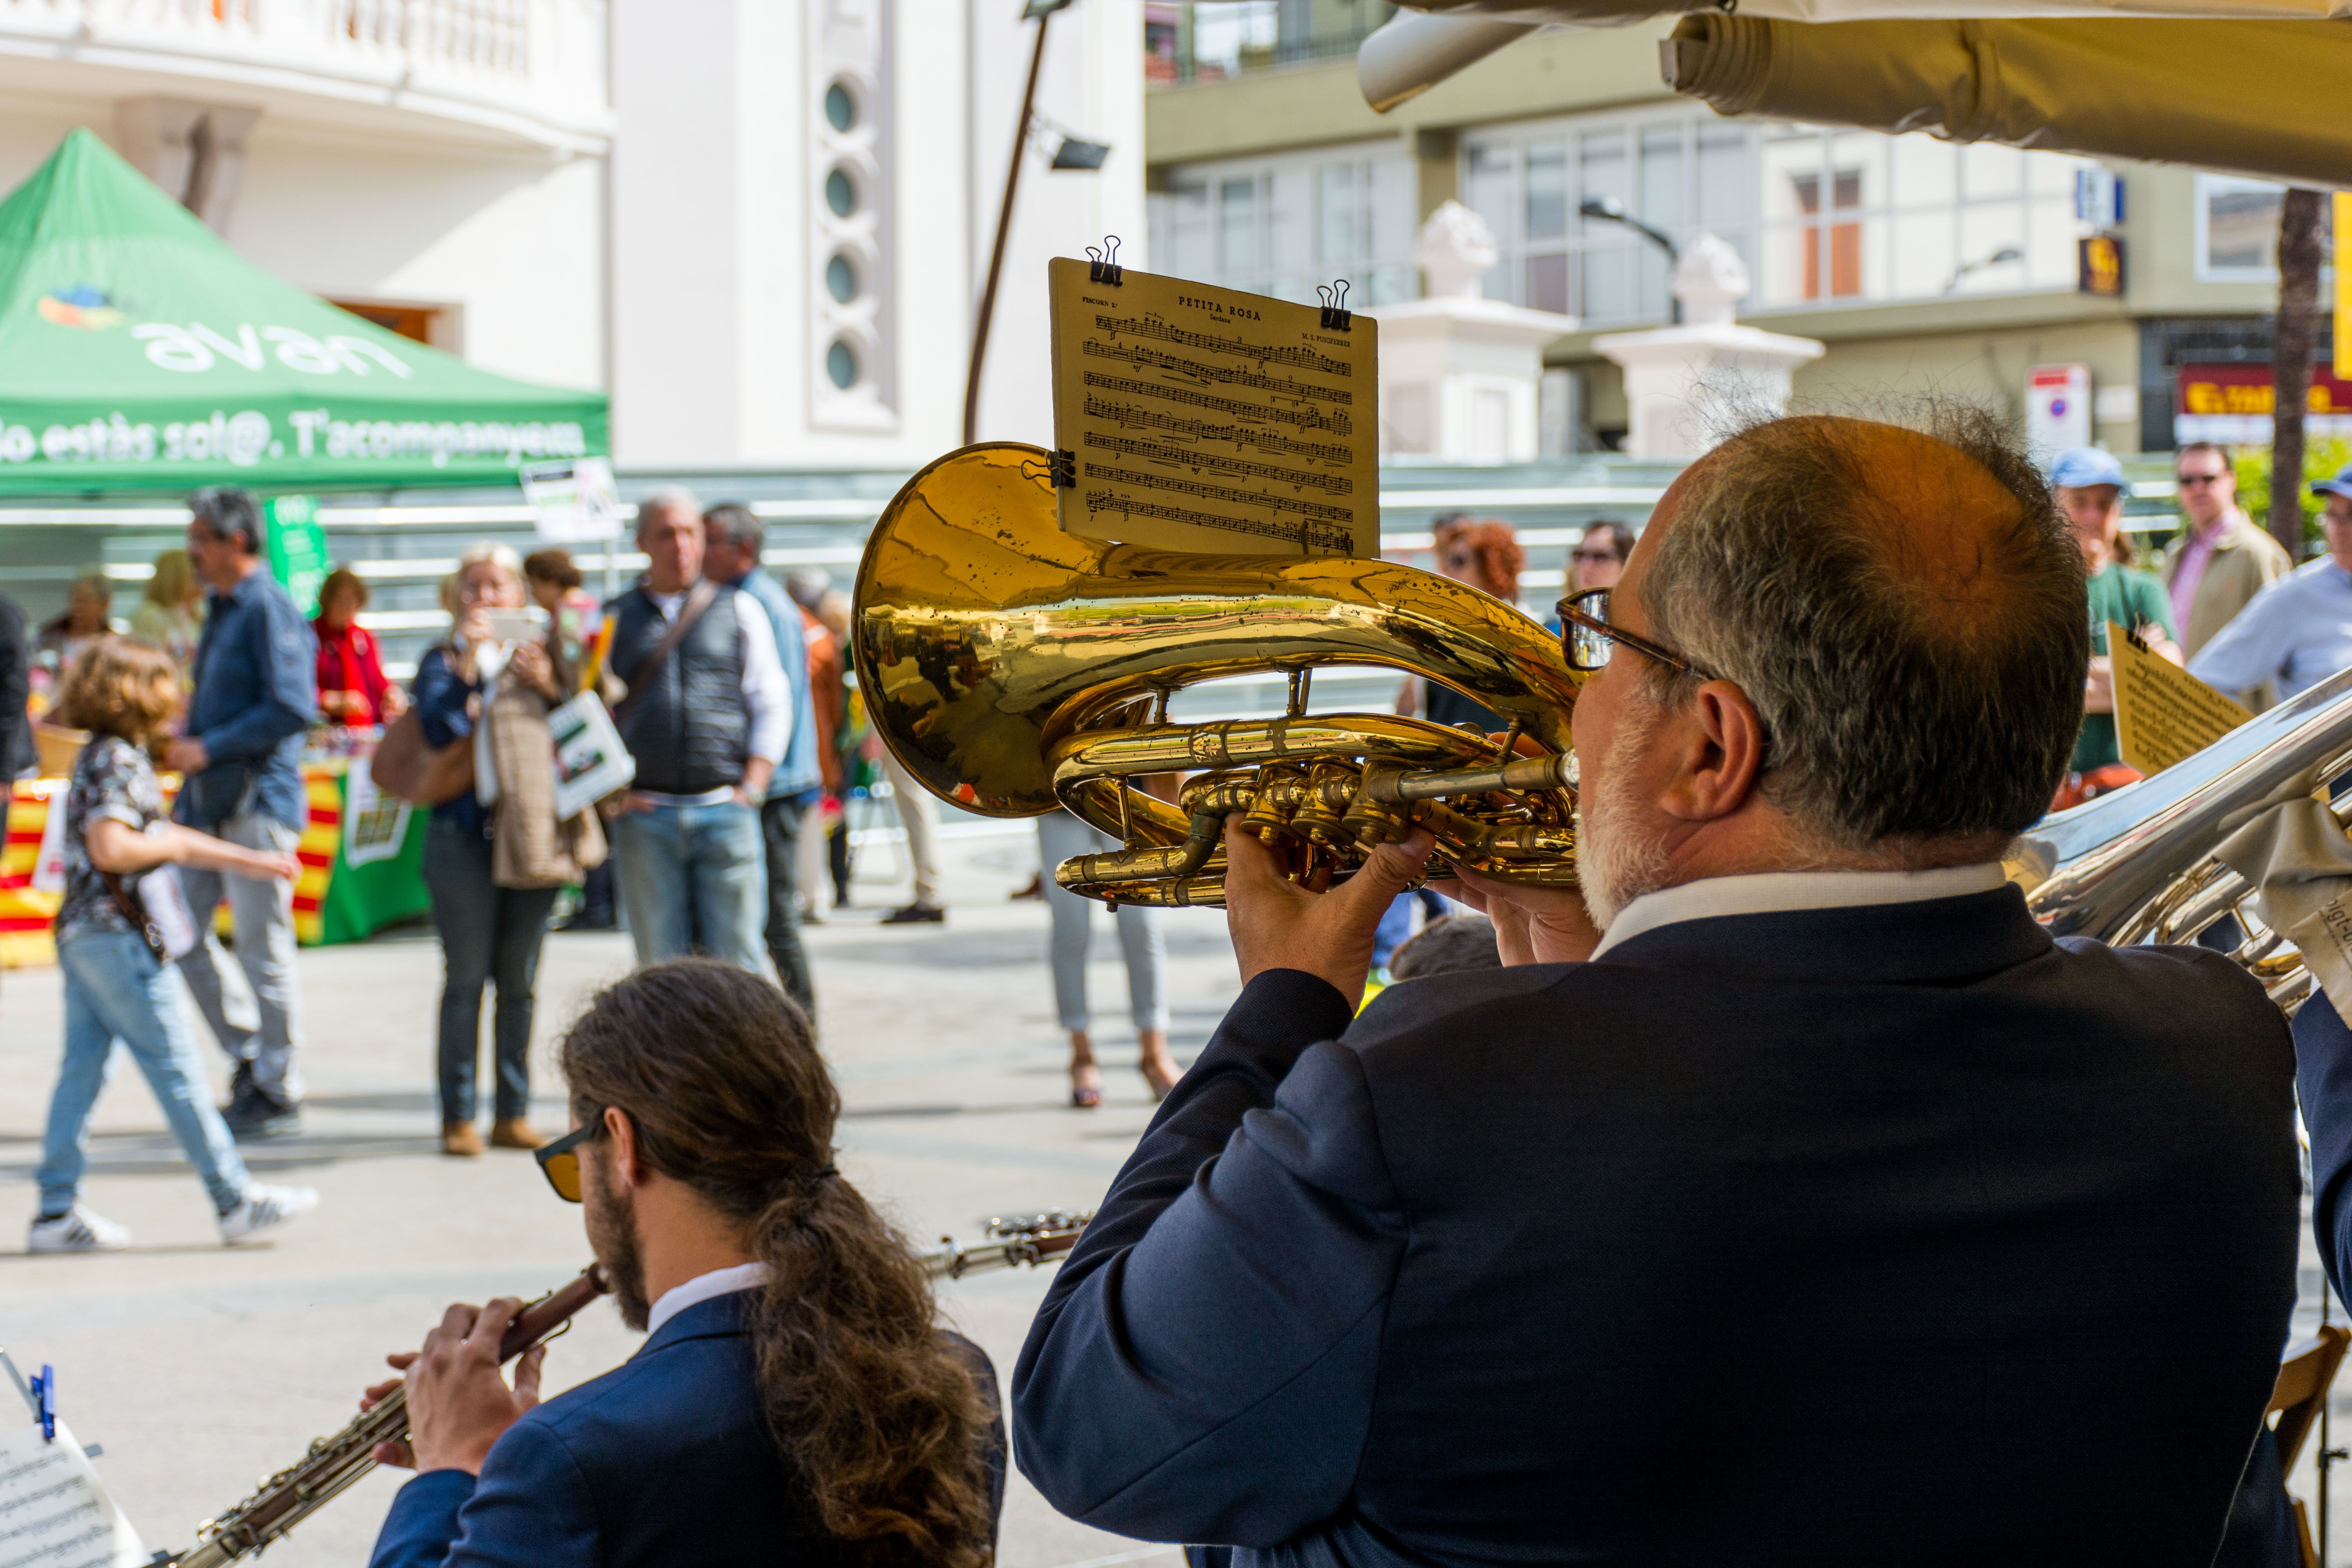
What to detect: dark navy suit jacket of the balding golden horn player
<box><xmin>1014</xmin><ymin>886</ymin><xmax>2300</xmax><ymax>1568</ymax></box>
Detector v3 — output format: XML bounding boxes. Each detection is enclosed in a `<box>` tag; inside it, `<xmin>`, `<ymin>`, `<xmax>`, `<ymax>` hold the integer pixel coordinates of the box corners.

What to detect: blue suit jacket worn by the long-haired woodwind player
<box><xmin>369</xmin><ymin>1293</ymin><xmax>1004</xmax><ymax>1568</ymax></box>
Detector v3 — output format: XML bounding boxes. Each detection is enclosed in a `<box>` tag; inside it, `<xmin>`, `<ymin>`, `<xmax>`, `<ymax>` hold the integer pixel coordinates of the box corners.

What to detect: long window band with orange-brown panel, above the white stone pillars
<box><xmin>1461</xmin><ymin>111</ymin><xmax>2093</xmax><ymax>327</ymax></box>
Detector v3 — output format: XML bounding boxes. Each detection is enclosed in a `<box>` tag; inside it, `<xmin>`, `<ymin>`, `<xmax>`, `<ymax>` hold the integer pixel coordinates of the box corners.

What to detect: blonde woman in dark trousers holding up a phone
<box><xmin>412</xmin><ymin>543</ymin><xmax>564</xmax><ymax>1157</ymax></box>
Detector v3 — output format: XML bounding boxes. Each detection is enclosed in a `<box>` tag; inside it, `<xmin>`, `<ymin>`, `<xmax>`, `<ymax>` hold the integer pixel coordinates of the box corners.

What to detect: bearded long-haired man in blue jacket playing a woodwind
<box><xmin>367</xmin><ymin>959</ymin><xmax>1004</xmax><ymax>1568</ymax></box>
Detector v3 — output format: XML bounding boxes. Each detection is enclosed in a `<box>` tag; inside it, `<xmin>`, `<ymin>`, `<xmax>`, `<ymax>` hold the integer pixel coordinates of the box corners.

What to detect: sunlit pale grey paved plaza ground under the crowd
<box><xmin>0</xmin><ymin>820</ymin><xmax>2352</xmax><ymax>1568</ymax></box>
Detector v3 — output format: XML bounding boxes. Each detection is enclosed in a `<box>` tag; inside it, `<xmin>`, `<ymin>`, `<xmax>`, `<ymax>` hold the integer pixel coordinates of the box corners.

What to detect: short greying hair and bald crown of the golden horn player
<box><xmin>1642</xmin><ymin>404</ymin><xmax>2091</xmax><ymax>849</ymax></box>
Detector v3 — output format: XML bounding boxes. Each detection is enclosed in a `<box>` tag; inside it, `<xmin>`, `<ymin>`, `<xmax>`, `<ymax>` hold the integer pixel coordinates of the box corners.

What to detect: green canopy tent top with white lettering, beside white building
<box><xmin>0</xmin><ymin>129</ymin><xmax>609</xmax><ymax>496</ymax></box>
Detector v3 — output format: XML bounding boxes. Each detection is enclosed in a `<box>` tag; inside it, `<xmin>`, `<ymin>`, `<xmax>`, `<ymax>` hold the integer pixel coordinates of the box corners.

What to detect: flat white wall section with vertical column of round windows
<box><xmin>614</xmin><ymin>0</ymin><xmax>1148</xmax><ymax>468</ymax></box>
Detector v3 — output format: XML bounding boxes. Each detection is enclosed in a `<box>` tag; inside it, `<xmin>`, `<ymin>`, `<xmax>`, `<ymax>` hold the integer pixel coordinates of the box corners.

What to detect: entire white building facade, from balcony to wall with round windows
<box><xmin>0</xmin><ymin>0</ymin><xmax>1148</xmax><ymax>470</ymax></box>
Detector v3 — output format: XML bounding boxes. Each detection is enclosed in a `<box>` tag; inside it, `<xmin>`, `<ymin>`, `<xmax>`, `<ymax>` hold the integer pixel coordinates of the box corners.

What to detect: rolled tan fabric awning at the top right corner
<box><xmin>1661</xmin><ymin>7</ymin><xmax>2352</xmax><ymax>186</ymax></box>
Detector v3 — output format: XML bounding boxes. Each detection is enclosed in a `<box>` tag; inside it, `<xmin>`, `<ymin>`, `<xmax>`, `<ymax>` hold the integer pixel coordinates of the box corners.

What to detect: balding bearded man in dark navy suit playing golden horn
<box><xmin>1014</xmin><ymin>414</ymin><xmax>2298</xmax><ymax>1568</ymax></box>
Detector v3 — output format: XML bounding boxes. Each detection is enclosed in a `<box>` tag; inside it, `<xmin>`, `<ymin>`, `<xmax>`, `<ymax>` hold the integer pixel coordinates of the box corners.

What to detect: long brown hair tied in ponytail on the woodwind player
<box><xmin>562</xmin><ymin>959</ymin><xmax>997</xmax><ymax>1568</ymax></box>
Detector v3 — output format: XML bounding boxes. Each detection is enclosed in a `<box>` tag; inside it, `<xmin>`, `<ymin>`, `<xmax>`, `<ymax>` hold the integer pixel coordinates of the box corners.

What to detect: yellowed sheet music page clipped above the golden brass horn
<box><xmin>1047</xmin><ymin>256</ymin><xmax>1381</xmax><ymax>557</ymax></box>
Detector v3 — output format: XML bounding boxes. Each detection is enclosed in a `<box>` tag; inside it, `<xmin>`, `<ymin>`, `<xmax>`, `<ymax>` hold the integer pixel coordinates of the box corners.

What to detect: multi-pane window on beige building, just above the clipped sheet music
<box><xmin>1150</xmin><ymin>143</ymin><xmax>1421</xmax><ymax>306</ymax></box>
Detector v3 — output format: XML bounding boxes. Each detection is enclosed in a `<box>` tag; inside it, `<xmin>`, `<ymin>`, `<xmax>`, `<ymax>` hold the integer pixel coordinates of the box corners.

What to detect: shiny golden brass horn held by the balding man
<box><xmin>851</xmin><ymin>442</ymin><xmax>1583</xmax><ymax>905</ymax></box>
